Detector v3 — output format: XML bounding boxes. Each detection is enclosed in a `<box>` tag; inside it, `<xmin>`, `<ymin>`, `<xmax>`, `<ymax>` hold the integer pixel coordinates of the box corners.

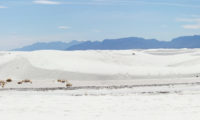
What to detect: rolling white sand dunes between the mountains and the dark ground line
<box><xmin>0</xmin><ymin>49</ymin><xmax>200</xmax><ymax>87</ymax></box>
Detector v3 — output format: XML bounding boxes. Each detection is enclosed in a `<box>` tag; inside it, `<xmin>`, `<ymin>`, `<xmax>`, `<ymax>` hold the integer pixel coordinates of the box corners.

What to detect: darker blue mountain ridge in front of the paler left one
<box><xmin>67</xmin><ymin>35</ymin><xmax>200</xmax><ymax>50</ymax></box>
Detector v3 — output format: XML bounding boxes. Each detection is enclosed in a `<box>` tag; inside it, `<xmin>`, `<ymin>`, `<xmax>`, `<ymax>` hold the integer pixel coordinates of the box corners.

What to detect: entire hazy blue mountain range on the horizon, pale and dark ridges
<box><xmin>12</xmin><ymin>35</ymin><xmax>200</xmax><ymax>51</ymax></box>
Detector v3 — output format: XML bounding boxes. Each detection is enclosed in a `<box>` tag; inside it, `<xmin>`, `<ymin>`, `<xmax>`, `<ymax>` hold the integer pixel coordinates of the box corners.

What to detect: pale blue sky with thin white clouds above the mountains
<box><xmin>0</xmin><ymin>0</ymin><xmax>200</xmax><ymax>50</ymax></box>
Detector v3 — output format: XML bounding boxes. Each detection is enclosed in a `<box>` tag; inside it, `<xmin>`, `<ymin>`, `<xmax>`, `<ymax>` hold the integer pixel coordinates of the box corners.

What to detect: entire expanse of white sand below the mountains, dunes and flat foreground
<box><xmin>0</xmin><ymin>49</ymin><xmax>200</xmax><ymax>120</ymax></box>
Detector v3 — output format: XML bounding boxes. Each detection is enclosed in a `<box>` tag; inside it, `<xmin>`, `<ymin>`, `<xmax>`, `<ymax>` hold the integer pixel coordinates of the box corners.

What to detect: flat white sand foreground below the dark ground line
<box><xmin>0</xmin><ymin>85</ymin><xmax>200</xmax><ymax>120</ymax></box>
